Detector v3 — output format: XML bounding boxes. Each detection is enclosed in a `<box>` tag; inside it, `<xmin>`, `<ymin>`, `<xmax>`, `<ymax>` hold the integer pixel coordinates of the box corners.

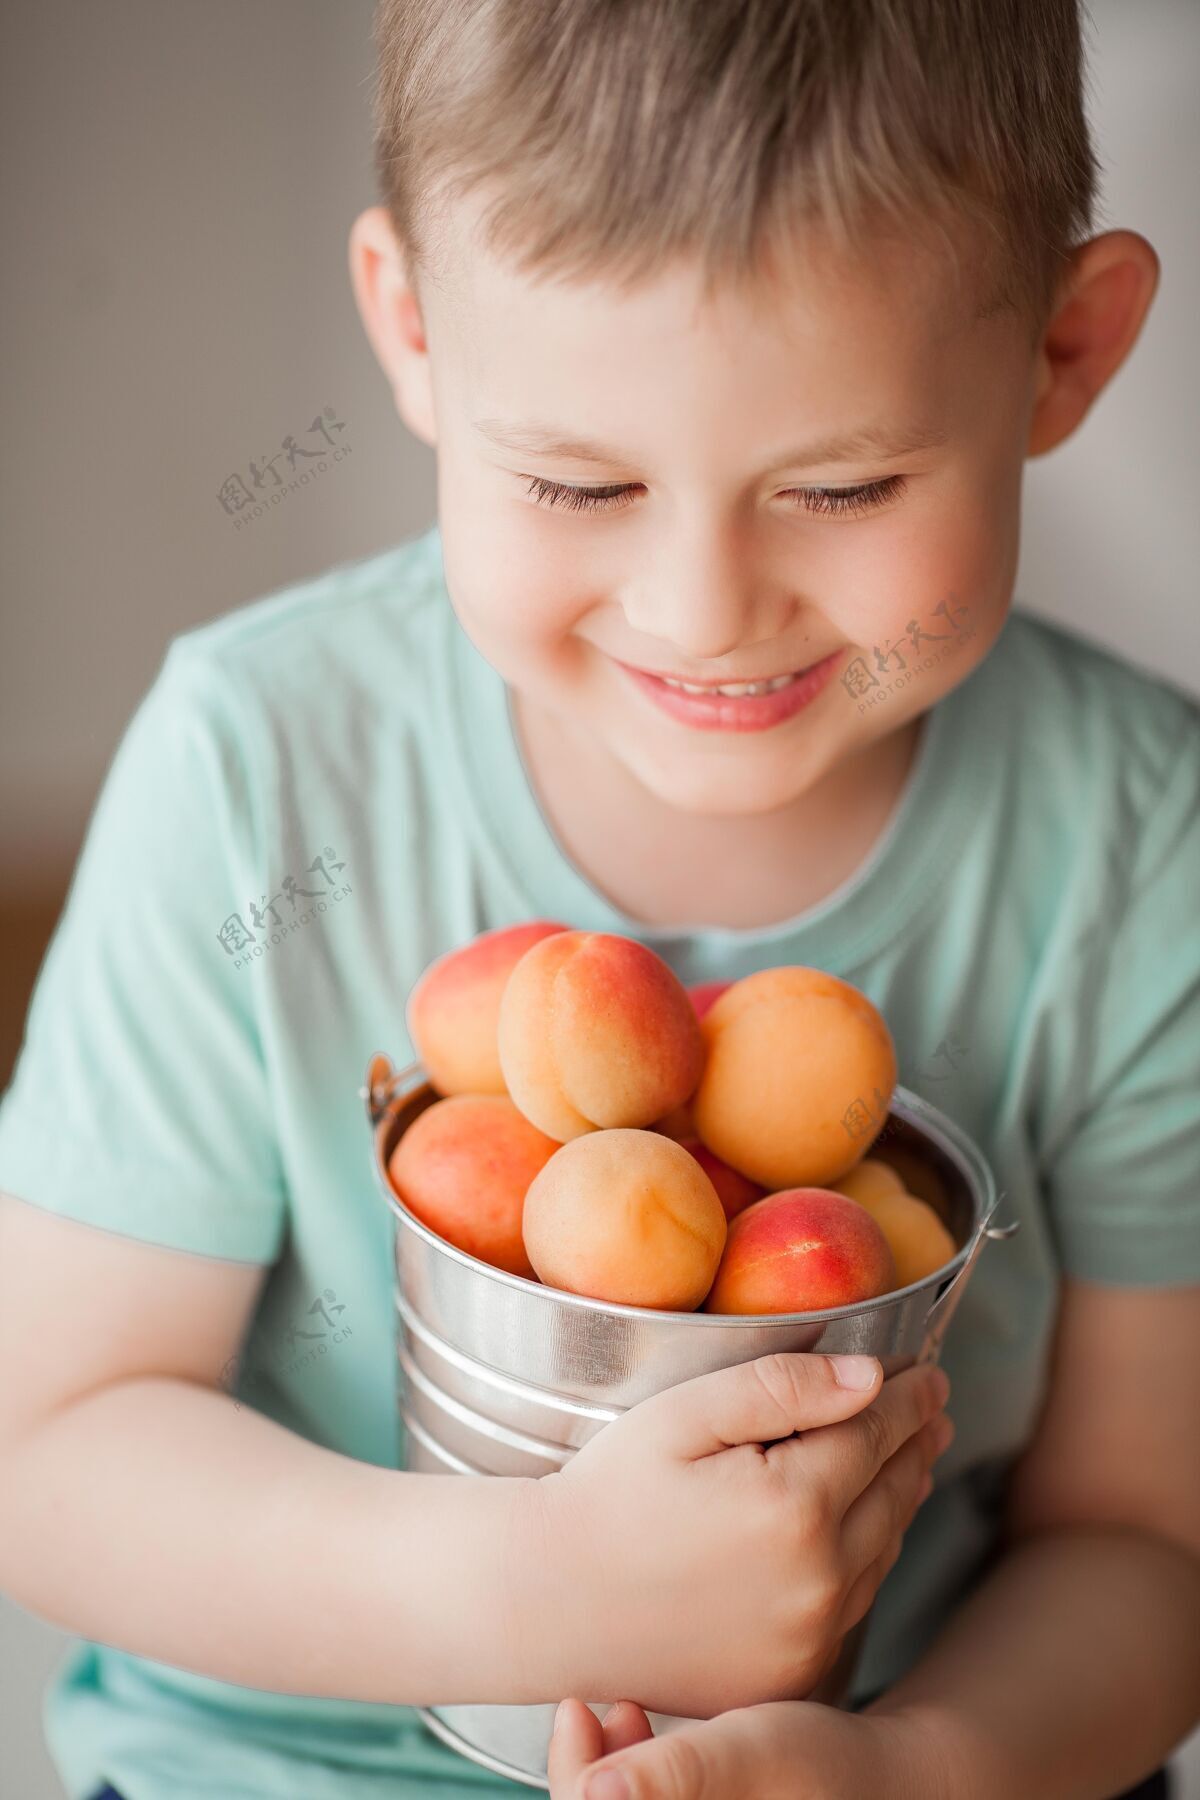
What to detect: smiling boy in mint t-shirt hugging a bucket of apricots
<box><xmin>0</xmin><ymin>0</ymin><xmax>1200</xmax><ymax>1800</ymax></box>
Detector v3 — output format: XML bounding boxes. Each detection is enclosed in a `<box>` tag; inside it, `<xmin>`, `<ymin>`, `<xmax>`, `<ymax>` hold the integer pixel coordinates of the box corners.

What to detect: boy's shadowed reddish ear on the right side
<box><xmin>1025</xmin><ymin>230</ymin><xmax>1159</xmax><ymax>455</ymax></box>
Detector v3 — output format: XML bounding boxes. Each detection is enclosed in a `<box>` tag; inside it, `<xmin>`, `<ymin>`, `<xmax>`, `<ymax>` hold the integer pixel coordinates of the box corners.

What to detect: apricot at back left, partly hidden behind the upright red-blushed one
<box><xmin>405</xmin><ymin>920</ymin><xmax>567</xmax><ymax>1094</ymax></box>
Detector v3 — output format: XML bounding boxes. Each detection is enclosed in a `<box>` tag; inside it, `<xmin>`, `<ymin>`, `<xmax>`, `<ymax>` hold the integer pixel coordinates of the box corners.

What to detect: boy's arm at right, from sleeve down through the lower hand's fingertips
<box><xmin>549</xmin><ymin>1280</ymin><xmax>1200</xmax><ymax>1800</ymax></box>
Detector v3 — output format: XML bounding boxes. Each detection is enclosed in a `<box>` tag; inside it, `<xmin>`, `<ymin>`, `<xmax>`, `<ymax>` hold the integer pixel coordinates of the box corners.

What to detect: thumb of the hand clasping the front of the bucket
<box><xmin>636</xmin><ymin>1350</ymin><xmax>883</xmax><ymax>1460</ymax></box>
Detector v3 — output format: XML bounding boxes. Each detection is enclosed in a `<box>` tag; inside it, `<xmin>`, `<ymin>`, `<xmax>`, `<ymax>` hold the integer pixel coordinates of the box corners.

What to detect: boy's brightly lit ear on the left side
<box><xmin>349</xmin><ymin>207</ymin><xmax>437</xmax><ymax>445</ymax></box>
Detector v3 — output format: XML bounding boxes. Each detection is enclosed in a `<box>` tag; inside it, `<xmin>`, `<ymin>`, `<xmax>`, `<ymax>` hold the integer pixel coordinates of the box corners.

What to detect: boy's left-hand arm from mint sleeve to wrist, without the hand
<box><xmin>0</xmin><ymin>1195</ymin><xmax>529</xmax><ymax>1705</ymax></box>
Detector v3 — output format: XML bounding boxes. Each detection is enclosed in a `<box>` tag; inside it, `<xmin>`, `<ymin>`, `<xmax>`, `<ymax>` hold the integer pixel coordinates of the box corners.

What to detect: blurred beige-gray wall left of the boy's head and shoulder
<box><xmin>0</xmin><ymin>0</ymin><xmax>434</xmax><ymax>886</ymax></box>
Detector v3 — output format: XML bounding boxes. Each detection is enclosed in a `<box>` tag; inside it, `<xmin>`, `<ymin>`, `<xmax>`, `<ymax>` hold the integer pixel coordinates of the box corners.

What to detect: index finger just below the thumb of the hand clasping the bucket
<box><xmin>768</xmin><ymin>1364</ymin><xmax>950</xmax><ymax>1517</ymax></box>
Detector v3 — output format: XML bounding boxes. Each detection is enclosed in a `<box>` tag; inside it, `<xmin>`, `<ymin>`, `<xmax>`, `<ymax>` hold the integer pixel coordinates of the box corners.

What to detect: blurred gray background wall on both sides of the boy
<box><xmin>0</xmin><ymin>0</ymin><xmax>1200</xmax><ymax>1800</ymax></box>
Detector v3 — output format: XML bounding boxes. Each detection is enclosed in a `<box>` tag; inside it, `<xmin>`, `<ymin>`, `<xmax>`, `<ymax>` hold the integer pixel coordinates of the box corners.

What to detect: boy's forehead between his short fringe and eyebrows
<box><xmin>428</xmin><ymin>186</ymin><xmax>999</xmax><ymax>428</ymax></box>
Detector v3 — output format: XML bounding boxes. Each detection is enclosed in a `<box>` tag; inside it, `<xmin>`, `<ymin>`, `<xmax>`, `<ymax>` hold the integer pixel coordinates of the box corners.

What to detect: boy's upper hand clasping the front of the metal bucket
<box><xmin>515</xmin><ymin>1354</ymin><xmax>952</xmax><ymax>1719</ymax></box>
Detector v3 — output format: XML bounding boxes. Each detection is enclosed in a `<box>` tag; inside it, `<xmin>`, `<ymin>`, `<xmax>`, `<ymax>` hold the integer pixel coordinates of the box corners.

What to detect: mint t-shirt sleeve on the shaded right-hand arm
<box><xmin>1043</xmin><ymin>702</ymin><xmax>1200</xmax><ymax>1285</ymax></box>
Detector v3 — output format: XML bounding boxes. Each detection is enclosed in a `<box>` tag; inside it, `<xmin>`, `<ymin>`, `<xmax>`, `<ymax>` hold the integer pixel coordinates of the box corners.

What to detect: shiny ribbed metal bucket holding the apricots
<box><xmin>360</xmin><ymin>1055</ymin><xmax>1016</xmax><ymax>1789</ymax></box>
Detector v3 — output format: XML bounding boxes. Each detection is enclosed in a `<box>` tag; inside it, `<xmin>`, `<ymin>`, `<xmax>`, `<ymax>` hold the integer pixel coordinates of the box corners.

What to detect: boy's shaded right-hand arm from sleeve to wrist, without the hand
<box><xmin>862</xmin><ymin>1280</ymin><xmax>1200</xmax><ymax>1800</ymax></box>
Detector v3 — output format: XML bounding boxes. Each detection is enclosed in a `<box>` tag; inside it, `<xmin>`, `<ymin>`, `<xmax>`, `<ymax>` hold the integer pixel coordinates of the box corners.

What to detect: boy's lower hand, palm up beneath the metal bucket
<box><xmin>547</xmin><ymin>1699</ymin><xmax>949</xmax><ymax>1800</ymax></box>
